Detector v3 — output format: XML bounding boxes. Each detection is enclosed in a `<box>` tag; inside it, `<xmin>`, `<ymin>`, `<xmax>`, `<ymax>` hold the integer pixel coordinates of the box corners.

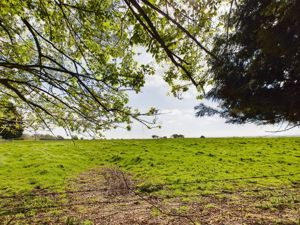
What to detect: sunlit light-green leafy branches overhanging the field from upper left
<box><xmin>0</xmin><ymin>0</ymin><xmax>220</xmax><ymax>132</ymax></box>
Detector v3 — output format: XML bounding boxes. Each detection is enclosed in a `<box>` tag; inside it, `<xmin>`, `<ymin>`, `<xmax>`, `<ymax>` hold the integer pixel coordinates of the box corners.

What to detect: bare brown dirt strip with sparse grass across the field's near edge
<box><xmin>0</xmin><ymin>168</ymin><xmax>300</xmax><ymax>225</ymax></box>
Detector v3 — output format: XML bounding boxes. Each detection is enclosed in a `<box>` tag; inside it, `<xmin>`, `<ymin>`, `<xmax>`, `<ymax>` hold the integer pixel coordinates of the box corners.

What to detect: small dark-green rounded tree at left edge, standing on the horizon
<box><xmin>0</xmin><ymin>99</ymin><xmax>24</xmax><ymax>139</ymax></box>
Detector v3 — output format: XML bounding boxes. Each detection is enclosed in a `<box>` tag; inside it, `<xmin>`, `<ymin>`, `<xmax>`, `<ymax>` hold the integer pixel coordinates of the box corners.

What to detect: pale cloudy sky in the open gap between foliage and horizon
<box><xmin>104</xmin><ymin>50</ymin><xmax>300</xmax><ymax>138</ymax></box>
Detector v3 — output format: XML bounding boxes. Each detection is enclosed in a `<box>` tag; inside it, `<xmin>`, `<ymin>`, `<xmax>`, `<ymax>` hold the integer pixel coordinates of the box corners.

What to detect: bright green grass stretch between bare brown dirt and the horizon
<box><xmin>0</xmin><ymin>137</ymin><xmax>300</xmax><ymax>224</ymax></box>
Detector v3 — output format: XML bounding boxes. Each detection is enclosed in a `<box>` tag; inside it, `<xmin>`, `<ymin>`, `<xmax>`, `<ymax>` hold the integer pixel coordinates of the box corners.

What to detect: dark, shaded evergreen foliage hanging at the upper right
<box><xmin>196</xmin><ymin>0</ymin><xmax>300</xmax><ymax>126</ymax></box>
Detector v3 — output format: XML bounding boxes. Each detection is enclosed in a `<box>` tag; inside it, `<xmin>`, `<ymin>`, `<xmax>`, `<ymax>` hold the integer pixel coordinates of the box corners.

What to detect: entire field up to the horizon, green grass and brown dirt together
<box><xmin>0</xmin><ymin>137</ymin><xmax>300</xmax><ymax>225</ymax></box>
